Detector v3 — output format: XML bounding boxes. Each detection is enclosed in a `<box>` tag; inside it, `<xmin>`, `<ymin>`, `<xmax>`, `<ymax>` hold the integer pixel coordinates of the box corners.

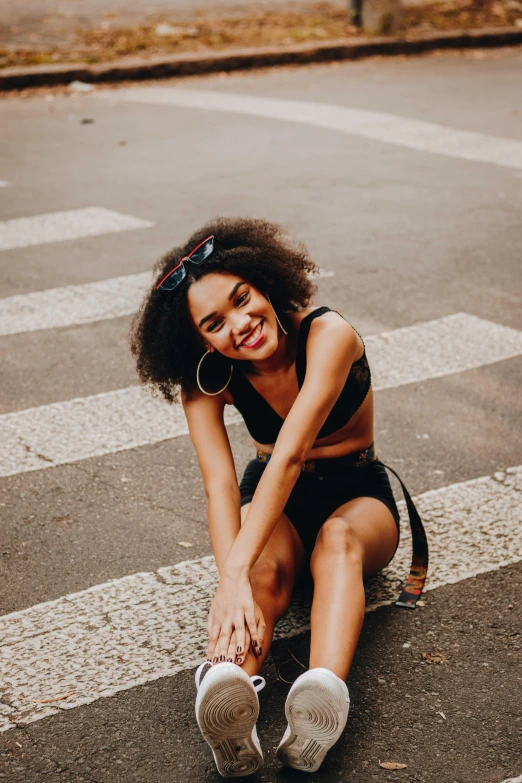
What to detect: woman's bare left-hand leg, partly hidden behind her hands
<box><xmin>237</xmin><ymin>504</ymin><xmax>304</xmax><ymax>676</ymax></box>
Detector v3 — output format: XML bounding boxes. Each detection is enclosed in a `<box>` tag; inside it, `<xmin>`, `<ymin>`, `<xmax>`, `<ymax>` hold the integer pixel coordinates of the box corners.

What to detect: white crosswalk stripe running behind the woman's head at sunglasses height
<box><xmin>0</xmin><ymin>269</ymin><xmax>334</xmax><ymax>336</ymax></box>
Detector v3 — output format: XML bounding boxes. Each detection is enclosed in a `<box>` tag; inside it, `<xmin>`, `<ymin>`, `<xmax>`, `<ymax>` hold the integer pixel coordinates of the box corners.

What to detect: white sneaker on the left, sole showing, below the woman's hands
<box><xmin>196</xmin><ymin>661</ymin><xmax>265</xmax><ymax>778</ymax></box>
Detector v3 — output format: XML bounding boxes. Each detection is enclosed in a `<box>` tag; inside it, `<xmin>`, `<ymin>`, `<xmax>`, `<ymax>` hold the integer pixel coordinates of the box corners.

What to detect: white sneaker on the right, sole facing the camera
<box><xmin>277</xmin><ymin>668</ymin><xmax>350</xmax><ymax>772</ymax></box>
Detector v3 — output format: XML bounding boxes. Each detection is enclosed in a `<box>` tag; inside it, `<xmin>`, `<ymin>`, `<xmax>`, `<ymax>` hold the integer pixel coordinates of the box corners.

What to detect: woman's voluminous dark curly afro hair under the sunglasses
<box><xmin>129</xmin><ymin>218</ymin><xmax>318</xmax><ymax>403</ymax></box>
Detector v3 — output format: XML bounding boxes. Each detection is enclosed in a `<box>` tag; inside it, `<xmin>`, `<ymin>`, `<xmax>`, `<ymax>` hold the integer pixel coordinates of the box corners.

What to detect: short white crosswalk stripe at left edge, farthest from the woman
<box><xmin>0</xmin><ymin>207</ymin><xmax>154</xmax><ymax>250</ymax></box>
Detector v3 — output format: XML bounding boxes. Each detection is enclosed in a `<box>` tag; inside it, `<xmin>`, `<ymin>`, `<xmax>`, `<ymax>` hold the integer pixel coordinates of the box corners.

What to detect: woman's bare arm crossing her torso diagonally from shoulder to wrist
<box><xmin>225</xmin><ymin>313</ymin><xmax>358</xmax><ymax>579</ymax></box>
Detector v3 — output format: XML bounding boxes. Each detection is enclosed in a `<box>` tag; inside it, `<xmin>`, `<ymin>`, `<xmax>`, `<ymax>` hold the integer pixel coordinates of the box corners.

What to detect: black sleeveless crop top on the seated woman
<box><xmin>228</xmin><ymin>307</ymin><xmax>371</xmax><ymax>444</ymax></box>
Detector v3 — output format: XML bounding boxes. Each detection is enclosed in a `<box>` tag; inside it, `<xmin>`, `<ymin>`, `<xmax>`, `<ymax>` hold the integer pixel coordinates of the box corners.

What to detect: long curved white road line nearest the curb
<box><xmin>102</xmin><ymin>87</ymin><xmax>522</xmax><ymax>174</ymax></box>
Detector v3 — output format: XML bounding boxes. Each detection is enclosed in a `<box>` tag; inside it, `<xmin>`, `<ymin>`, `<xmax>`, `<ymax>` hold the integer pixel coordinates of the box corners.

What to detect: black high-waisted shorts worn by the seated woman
<box><xmin>239</xmin><ymin>459</ymin><xmax>399</xmax><ymax>557</ymax></box>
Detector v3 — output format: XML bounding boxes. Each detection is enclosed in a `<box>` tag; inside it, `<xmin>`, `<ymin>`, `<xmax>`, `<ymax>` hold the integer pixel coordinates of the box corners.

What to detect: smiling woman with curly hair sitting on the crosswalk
<box><xmin>131</xmin><ymin>218</ymin><xmax>422</xmax><ymax>777</ymax></box>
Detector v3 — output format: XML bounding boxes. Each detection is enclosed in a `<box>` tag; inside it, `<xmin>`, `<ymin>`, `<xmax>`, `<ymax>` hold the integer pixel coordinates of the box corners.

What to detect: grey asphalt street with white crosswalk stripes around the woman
<box><xmin>0</xmin><ymin>48</ymin><xmax>522</xmax><ymax>783</ymax></box>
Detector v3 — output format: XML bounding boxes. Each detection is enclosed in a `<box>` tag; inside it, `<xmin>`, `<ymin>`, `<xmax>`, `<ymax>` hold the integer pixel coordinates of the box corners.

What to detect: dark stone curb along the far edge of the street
<box><xmin>0</xmin><ymin>27</ymin><xmax>522</xmax><ymax>91</ymax></box>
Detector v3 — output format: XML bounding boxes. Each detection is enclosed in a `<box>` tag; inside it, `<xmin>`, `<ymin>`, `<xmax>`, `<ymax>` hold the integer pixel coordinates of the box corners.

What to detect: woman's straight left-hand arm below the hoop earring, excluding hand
<box><xmin>183</xmin><ymin>395</ymin><xmax>241</xmax><ymax>575</ymax></box>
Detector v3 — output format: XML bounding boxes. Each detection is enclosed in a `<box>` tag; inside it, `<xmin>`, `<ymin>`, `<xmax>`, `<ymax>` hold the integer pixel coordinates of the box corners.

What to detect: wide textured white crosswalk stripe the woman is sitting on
<box><xmin>0</xmin><ymin>466</ymin><xmax>522</xmax><ymax>731</ymax></box>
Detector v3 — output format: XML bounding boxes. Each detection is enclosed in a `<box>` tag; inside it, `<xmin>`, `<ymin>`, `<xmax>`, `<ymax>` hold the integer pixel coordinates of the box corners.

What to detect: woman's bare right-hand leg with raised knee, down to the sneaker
<box><xmin>310</xmin><ymin>498</ymin><xmax>398</xmax><ymax>680</ymax></box>
